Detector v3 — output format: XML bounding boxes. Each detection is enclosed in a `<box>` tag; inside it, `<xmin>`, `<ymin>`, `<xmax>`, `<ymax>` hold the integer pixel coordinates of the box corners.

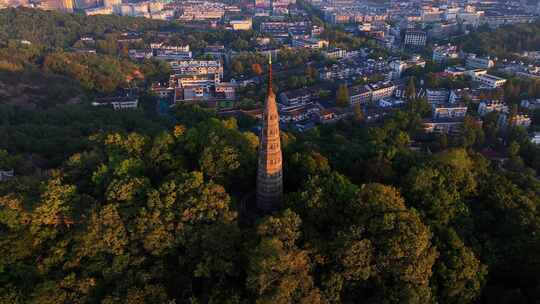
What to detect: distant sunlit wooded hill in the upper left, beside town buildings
<box><xmin>0</xmin><ymin>8</ymin><xmax>166</xmax><ymax>108</ymax></box>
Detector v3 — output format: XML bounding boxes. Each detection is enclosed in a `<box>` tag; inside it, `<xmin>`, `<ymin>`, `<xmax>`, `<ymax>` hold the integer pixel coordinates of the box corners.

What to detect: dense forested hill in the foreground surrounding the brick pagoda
<box><xmin>0</xmin><ymin>107</ymin><xmax>540</xmax><ymax>304</ymax></box>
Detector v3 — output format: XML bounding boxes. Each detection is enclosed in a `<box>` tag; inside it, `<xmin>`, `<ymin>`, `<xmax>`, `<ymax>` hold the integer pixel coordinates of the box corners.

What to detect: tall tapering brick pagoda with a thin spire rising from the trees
<box><xmin>257</xmin><ymin>57</ymin><xmax>283</xmax><ymax>212</ymax></box>
